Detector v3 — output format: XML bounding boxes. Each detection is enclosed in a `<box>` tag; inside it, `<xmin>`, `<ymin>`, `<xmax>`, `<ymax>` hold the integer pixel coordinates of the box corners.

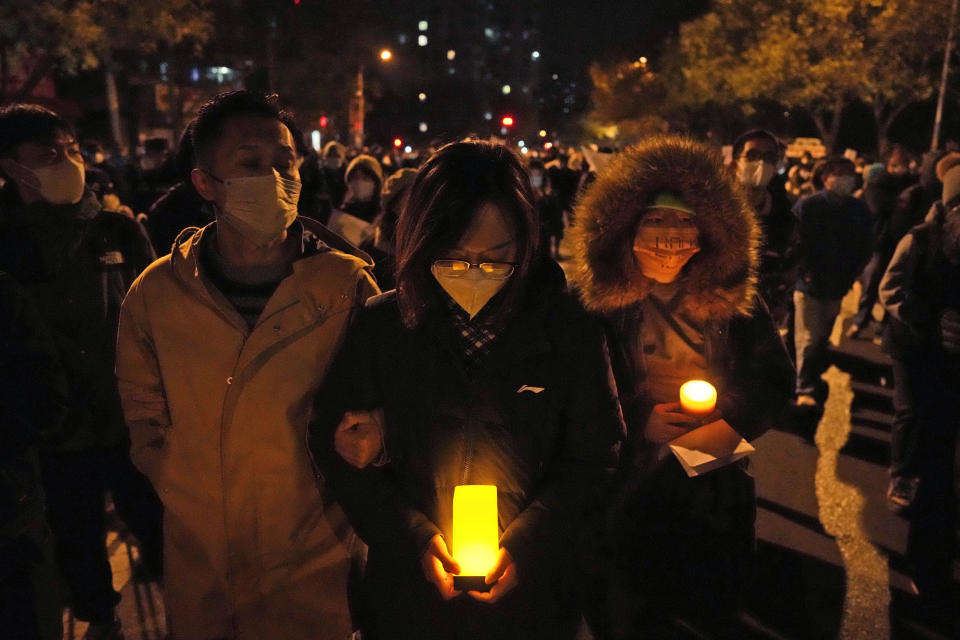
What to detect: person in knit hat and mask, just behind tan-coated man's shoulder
<box><xmin>328</xmin><ymin>154</ymin><xmax>383</xmax><ymax>246</ymax></box>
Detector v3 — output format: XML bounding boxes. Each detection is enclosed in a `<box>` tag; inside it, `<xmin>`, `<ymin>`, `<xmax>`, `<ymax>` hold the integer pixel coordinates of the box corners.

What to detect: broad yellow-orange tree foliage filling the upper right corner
<box><xmin>678</xmin><ymin>0</ymin><xmax>950</xmax><ymax>151</ymax></box>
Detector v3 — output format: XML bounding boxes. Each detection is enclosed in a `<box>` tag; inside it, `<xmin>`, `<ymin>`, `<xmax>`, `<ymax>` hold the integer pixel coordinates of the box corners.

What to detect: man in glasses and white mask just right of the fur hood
<box><xmin>731</xmin><ymin>129</ymin><xmax>797</xmax><ymax>330</ymax></box>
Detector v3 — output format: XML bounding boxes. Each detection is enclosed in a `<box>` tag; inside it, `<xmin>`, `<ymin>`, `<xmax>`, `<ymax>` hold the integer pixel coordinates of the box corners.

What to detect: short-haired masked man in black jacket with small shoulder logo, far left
<box><xmin>0</xmin><ymin>105</ymin><xmax>161</xmax><ymax>638</ymax></box>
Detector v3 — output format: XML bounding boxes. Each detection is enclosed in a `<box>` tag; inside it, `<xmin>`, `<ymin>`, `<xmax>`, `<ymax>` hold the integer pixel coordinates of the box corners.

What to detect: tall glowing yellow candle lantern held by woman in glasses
<box><xmin>453</xmin><ymin>484</ymin><xmax>500</xmax><ymax>591</ymax></box>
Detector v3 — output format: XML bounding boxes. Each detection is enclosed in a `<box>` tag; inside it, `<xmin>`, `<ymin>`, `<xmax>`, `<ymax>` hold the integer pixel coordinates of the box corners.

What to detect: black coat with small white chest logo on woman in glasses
<box><xmin>311</xmin><ymin>261</ymin><xmax>623</xmax><ymax>638</ymax></box>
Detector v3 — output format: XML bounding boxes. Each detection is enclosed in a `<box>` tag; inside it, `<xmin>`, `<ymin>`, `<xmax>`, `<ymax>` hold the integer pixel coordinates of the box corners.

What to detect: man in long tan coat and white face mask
<box><xmin>117</xmin><ymin>91</ymin><xmax>378</xmax><ymax>639</ymax></box>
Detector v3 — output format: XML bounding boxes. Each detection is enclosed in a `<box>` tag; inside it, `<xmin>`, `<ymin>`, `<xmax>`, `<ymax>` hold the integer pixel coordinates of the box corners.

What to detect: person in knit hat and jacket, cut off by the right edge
<box><xmin>880</xmin><ymin>153</ymin><xmax>960</xmax><ymax>624</ymax></box>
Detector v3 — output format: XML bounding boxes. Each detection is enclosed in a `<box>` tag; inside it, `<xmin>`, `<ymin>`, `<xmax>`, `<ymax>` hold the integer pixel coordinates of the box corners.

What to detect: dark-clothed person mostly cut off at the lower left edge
<box><xmin>0</xmin><ymin>272</ymin><xmax>67</xmax><ymax>640</ymax></box>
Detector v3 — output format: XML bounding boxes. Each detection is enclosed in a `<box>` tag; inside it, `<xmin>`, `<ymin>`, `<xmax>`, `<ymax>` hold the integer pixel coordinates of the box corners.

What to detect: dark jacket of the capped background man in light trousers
<box><xmin>793</xmin><ymin>190</ymin><xmax>874</xmax><ymax>300</ymax></box>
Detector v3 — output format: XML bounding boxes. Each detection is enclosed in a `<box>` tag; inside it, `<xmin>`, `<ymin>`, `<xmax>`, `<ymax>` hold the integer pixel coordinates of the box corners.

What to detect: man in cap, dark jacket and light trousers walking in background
<box><xmin>793</xmin><ymin>158</ymin><xmax>873</xmax><ymax>406</ymax></box>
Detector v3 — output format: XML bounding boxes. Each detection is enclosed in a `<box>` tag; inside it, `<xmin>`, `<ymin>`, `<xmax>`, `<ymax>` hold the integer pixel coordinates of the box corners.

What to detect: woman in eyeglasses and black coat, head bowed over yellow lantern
<box><xmin>309</xmin><ymin>141</ymin><xmax>623</xmax><ymax>640</ymax></box>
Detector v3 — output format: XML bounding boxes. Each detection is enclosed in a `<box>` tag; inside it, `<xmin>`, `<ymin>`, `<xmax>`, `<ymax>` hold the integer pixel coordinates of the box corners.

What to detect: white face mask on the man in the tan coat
<box><xmin>211</xmin><ymin>169</ymin><xmax>300</xmax><ymax>247</ymax></box>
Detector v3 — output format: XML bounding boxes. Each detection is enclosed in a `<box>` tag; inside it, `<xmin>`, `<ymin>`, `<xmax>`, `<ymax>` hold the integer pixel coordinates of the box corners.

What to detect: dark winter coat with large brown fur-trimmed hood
<box><xmin>572</xmin><ymin>137</ymin><xmax>795</xmax><ymax>637</ymax></box>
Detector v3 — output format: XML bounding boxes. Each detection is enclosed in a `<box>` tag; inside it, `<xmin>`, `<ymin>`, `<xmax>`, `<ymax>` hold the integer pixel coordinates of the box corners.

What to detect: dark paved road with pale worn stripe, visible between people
<box><xmin>64</xmin><ymin>286</ymin><xmax>949</xmax><ymax>640</ymax></box>
